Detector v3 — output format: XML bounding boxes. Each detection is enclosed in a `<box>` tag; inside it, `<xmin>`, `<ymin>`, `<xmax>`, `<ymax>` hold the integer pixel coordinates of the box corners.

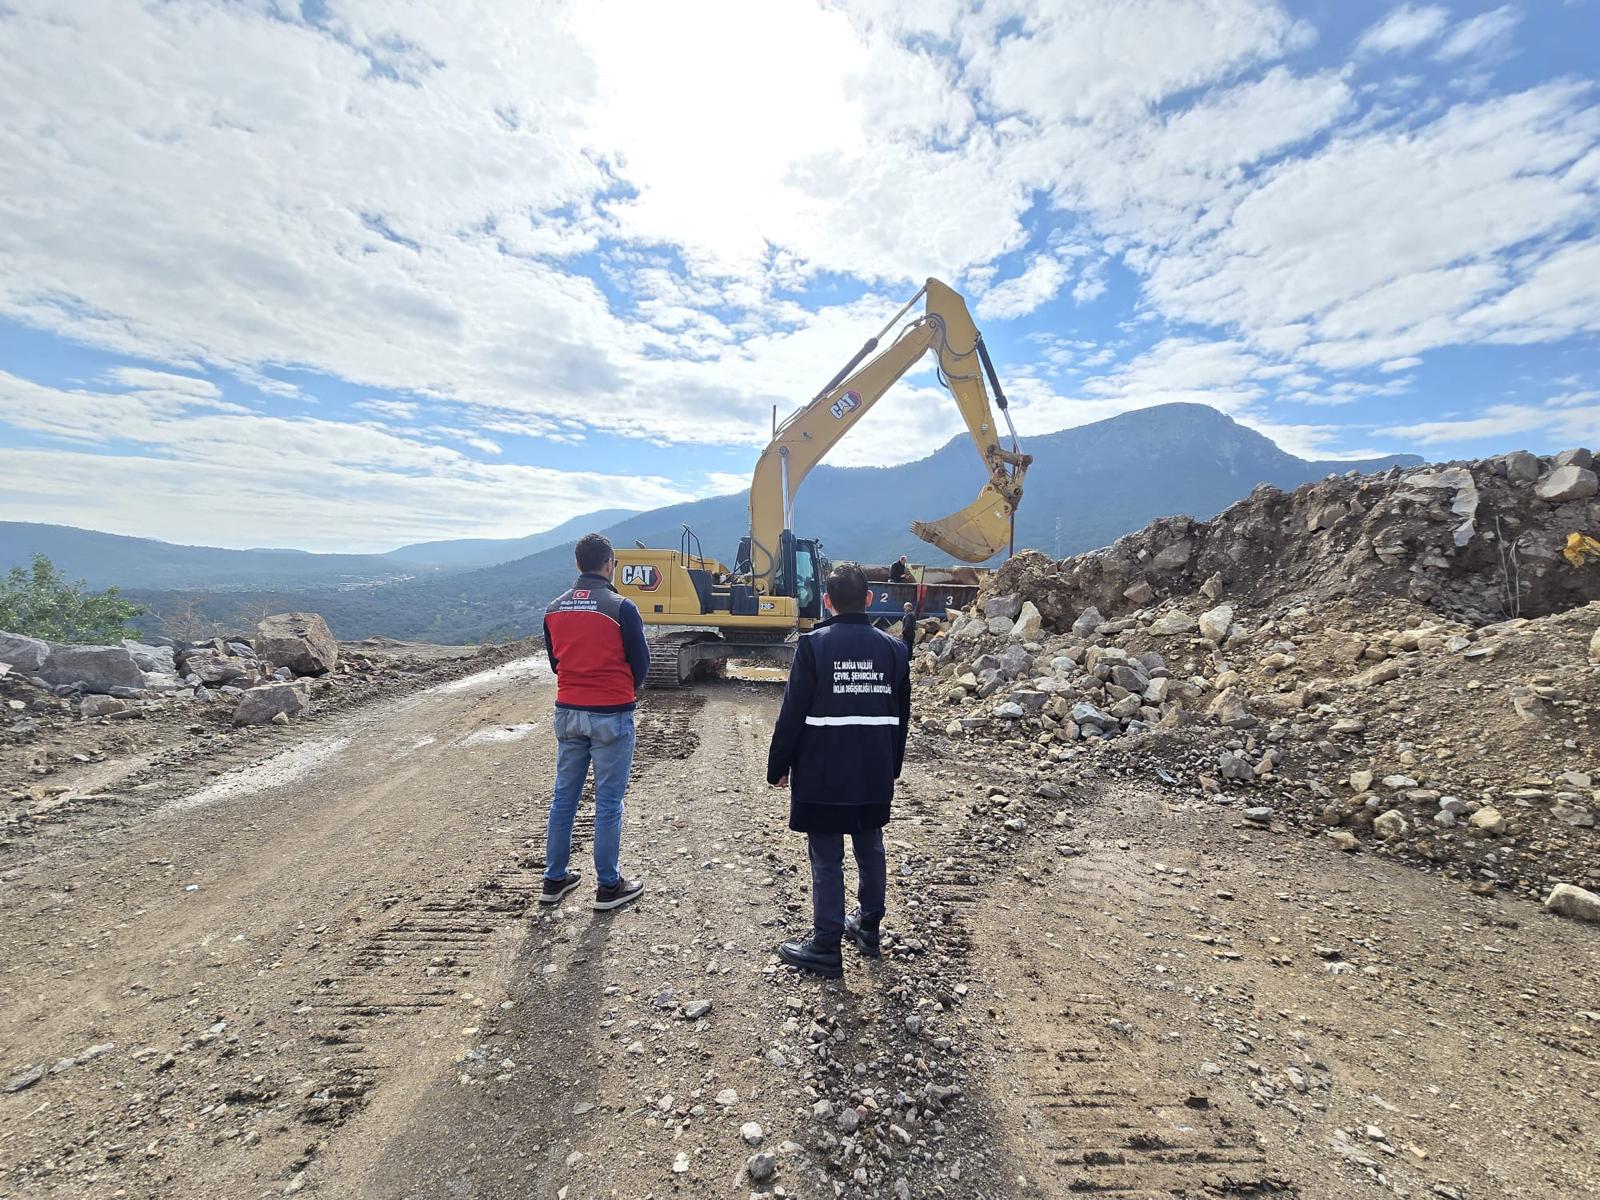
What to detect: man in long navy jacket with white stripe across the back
<box><xmin>766</xmin><ymin>563</ymin><xmax>910</xmax><ymax>979</ymax></box>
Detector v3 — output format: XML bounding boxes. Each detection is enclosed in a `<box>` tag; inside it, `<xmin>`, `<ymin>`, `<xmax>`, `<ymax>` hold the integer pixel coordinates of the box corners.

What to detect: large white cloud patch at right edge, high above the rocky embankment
<box><xmin>1149</xmin><ymin>83</ymin><xmax>1600</xmax><ymax>368</ymax></box>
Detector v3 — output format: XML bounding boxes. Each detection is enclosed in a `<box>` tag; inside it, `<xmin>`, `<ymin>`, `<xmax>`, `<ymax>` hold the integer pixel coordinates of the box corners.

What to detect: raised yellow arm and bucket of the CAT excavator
<box><xmin>741</xmin><ymin>278</ymin><xmax>1034</xmax><ymax>592</ymax></box>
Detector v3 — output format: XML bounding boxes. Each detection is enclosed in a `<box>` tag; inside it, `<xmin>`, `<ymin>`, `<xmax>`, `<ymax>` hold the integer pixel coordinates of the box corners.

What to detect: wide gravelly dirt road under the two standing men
<box><xmin>0</xmin><ymin>662</ymin><xmax>1600</xmax><ymax>1200</ymax></box>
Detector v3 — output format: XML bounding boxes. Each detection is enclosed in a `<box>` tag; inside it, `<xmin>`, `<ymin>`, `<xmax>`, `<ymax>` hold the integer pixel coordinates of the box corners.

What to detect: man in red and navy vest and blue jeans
<box><xmin>539</xmin><ymin>533</ymin><xmax>650</xmax><ymax>912</ymax></box>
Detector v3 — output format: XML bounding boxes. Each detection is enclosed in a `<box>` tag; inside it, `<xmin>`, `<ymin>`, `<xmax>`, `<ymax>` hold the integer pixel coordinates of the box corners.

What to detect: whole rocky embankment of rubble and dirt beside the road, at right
<box><xmin>914</xmin><ymin>450</ymin><xmax>1600</xmax><ymax>920</ymax></box>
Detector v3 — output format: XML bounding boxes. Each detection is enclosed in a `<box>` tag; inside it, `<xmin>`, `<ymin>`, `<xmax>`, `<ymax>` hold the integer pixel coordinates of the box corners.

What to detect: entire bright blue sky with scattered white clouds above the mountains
<box><xmin>0</xmin><ymin>0</ymin><xmax>1600</xmax><ymax>549</ymax></box>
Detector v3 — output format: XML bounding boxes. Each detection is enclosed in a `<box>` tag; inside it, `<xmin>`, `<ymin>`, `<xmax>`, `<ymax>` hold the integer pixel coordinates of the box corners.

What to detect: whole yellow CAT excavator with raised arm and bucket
<box><xmin>614</xmin><ymin>278</ymin><xmax>1034</xmax><ymax>686</ymax></box>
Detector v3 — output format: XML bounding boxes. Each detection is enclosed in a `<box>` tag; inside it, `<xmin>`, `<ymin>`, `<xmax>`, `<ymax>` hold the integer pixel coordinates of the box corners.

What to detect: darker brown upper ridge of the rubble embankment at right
<box><xmin>992</xmin><ymin>450</ymin><xmax>1600</xmax><ymax>629</ymax></box>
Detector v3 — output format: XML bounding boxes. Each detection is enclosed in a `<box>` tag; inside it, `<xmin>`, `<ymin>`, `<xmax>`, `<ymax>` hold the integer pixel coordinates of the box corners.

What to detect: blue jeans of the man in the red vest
<box><xmin>544</xmin><ymin>709</ymin><xmax>634</xmax><ymax>888</ymax></box>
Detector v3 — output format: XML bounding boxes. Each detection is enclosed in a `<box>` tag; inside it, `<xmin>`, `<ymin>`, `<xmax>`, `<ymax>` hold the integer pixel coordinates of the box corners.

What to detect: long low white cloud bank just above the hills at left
<box><xmin>0</xmin><ymin>371</ymin><xmax>690</xmax><ymax>550</ymax></box>
